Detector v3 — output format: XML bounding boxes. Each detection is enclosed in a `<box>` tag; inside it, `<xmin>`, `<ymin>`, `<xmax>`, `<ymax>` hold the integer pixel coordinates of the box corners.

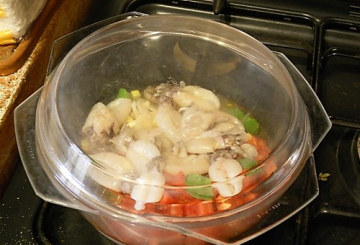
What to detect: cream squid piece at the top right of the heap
<box><xmin>172</xmin><ymin>85</ymin><xmax>220</xmax><ymax>111</ymax></box>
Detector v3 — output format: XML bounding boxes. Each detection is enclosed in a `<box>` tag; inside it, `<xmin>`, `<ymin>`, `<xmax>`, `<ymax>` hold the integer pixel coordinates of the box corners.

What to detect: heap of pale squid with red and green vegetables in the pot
<box><xmin>82</xmin><ymin>80</ymin><xmax>276</xmax><ymax>216</ymax></box>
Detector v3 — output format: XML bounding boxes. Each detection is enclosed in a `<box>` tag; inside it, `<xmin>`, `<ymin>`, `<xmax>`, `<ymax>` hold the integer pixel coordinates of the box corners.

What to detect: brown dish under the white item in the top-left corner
<box><xmin>0</xmin><ymin>0</ymin><xmax>59</xmax><ymax>76</ymax></box>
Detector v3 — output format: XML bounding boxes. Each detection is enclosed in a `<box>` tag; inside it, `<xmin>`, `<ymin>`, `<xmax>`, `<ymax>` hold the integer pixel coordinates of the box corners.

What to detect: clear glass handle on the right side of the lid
<box><xmin>274</xmin><ymin>52</ymin><xmax>331</xmax><ymax>151</ymax></box>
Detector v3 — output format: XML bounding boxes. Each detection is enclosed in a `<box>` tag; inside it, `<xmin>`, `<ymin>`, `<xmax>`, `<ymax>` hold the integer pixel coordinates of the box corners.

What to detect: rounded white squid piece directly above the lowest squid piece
<box><xmin>126</xmin><ymin>139</ymin><xmax>161</xmax><ymax>175</ymax></box>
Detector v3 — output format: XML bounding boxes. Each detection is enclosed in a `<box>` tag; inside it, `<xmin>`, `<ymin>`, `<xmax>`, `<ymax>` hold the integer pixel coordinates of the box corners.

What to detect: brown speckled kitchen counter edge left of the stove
<box><xmin>0</xmin><ymin>0</ymin><xmax>116</xmax><ymax>198</ymax></box>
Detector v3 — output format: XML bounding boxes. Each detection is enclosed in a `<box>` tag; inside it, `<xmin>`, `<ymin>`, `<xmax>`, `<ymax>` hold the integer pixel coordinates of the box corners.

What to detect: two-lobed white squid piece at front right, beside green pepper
<box><xmin>209</xmin><ymin>157</ymin><xmax>245</xmax><ymax>197</ymax></box>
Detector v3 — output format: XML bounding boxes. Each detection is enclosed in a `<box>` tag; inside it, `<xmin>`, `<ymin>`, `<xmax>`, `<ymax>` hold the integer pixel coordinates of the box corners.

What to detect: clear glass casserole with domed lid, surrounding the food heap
<box><xmin>15</xmin><ymin>13</ymin><xmax>331</xmax><ymax>244</ymax></box>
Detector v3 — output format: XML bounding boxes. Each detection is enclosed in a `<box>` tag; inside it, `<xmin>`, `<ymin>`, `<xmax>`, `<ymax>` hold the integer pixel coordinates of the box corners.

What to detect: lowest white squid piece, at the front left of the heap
<box><xmin>131</xmin><ymin>168</ymin><xmax>165</xmax><ymax>210</ymax></box>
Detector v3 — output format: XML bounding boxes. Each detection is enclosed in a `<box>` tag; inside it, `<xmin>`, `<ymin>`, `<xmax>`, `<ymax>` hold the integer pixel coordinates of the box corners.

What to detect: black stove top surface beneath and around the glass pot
<box><xmin>0</xmin><ymin>0</ymin><xmax>360</xmax><ymax>245</ymax></box>
